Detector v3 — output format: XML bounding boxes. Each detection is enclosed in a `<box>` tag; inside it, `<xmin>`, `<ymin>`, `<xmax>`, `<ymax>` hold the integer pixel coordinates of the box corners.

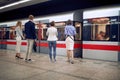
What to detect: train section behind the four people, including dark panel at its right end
<box><xmin>0</xmin><ymin>10</ymin><xmax>82</xmax><ymax>57</ymax></box>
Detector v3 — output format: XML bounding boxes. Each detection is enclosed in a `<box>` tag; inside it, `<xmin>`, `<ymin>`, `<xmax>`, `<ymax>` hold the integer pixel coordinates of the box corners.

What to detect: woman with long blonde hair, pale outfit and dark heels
<box><xmin>15</xmin><ymin>21</ymin><xmax>24</xmax><ymax>59</ymax></box>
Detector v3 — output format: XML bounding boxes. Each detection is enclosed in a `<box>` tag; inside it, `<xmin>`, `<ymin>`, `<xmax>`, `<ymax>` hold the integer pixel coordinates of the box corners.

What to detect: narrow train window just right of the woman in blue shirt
<box><xmin>75</xmin><ymin>22</ymin><xmax>82</xmax><ymax>40</ymax></box>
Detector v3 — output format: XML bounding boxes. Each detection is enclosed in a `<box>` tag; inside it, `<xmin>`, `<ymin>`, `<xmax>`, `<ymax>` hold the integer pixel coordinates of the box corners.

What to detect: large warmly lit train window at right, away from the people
<box><xmin>91</xmin><ymin>18</ymin><xmax>110</xmax><ymax>40</ymax></box>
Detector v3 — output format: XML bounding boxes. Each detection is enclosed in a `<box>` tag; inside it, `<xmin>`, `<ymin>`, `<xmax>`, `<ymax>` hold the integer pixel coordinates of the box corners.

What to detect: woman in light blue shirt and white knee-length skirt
<box><xmin>64</xmin><ymin>20</ymin><xmax>76</xmax><ymax>64</ymax></box>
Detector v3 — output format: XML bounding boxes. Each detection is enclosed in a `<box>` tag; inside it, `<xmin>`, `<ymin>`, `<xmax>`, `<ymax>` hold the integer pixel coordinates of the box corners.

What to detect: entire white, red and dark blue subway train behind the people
<box><xmin>0</xmin><ymin>6</ymin><xmax>120</xmax><ymax>61</ymax></box>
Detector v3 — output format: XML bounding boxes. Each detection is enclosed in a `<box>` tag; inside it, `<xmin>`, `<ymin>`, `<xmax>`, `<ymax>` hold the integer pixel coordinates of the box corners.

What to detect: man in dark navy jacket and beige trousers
<box><xmin>25</xmin><ymin>15</ymin><xmax>36</xmax><ymax>61</ymax></box>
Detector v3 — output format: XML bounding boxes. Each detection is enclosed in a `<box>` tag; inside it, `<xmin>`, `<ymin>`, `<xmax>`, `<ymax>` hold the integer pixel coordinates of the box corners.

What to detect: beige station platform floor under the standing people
<box><xmin>0</xmin><ymin>50</ymin><xmax>120</xmax><ymax>80</ymax></box>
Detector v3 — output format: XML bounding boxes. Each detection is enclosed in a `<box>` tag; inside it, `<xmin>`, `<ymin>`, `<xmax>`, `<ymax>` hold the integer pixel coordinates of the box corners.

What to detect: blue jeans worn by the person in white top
<box><xmin>48</xmin><ymin>41</ymin><xmax>56</xmax><ymax>60</ymax></box>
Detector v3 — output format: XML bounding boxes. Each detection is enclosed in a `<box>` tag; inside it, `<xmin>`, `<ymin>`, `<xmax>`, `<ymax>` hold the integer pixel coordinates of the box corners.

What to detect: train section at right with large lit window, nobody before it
<box><xmin>83</xmin><ymin>7</ymin><xmax>120</xmax><ymax>61</ymax></box>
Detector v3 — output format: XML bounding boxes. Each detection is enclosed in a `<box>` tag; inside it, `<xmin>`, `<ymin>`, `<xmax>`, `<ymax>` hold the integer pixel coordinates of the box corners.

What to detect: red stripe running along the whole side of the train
<box><xmin>0</xmin><ymin>41</ymin><xmax>120</xmax><ymax>51</ymax></box>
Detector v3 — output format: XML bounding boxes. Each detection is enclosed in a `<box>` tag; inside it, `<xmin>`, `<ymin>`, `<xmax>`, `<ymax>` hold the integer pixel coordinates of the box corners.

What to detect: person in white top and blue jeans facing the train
<box><xmin>46</xmin><ymin>21</ymin><xmax>58</xmax><ymax>62</ymax></box>
